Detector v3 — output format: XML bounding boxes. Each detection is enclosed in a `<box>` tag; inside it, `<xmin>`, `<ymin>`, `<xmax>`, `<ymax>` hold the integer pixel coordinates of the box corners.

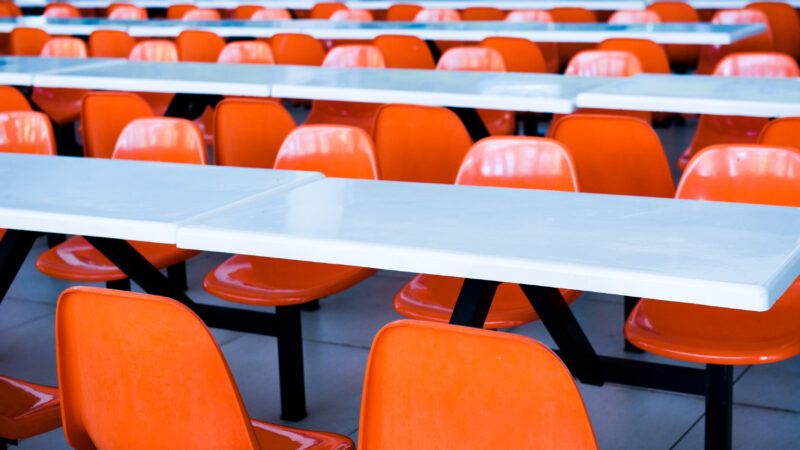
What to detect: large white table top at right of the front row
<box><xmin>178</xmin><ymin>178</ymin><xmax>800</xmax><ymax>311</ymax></box>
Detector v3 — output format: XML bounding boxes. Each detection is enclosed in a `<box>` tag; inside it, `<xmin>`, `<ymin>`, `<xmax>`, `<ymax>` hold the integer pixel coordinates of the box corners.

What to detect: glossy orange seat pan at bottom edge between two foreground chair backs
<box><xmin>250</xmin><ymin>419</ymin><xmax>355</xmax><ymax>450</ymax></box>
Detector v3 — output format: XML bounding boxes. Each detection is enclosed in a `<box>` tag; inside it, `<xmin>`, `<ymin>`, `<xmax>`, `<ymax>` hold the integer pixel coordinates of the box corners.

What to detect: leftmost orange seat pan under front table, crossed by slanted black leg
<box><xmin>36</xmin><ymin>236</ymin><xmax>199</xmax><ymax>282</ymax></box>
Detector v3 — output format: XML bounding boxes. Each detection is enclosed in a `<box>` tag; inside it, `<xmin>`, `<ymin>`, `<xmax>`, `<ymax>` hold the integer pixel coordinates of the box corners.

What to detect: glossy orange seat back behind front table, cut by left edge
<box><xmin>0</xmin><ymin>111</ymin><xmax>56</xmax><ymax>155</ymax></box>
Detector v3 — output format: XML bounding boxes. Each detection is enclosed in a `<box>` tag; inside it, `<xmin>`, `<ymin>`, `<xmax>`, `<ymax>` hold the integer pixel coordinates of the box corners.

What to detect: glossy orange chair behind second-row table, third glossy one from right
<box><xmin>436</xmin><ymin>47</ymin><xmax>517</xmax><ymax>136</ymax></box>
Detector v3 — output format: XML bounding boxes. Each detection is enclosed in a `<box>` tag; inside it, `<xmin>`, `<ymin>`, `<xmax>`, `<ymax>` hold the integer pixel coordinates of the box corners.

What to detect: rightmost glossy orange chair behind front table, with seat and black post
<box><xmin>625</xmin><ymin>144</ymin><xmax>800</xmax><ymax>448</ymax></box>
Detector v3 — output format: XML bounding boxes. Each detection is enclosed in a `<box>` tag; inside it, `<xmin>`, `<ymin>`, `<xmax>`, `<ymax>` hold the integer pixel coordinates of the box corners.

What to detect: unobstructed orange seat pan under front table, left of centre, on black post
<box><xmin>203</xmin><ymin>255</ymin><xmax>375</xmax><ymax>306</ymax></box>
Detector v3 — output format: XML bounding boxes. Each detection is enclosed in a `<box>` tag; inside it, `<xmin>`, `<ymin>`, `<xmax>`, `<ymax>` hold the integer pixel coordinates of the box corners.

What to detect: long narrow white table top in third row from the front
<box><xmin>0</xmin><ymin>16</ymin><xmax>764</xmax><ymax>45</ymax></box>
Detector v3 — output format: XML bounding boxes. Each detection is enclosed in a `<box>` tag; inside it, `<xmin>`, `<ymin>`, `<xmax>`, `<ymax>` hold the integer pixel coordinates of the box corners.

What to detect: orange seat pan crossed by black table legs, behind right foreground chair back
<box><xmin>394</xmin><ymin>275</ymin><xmax>581</xmax><ymax>329</ymax></box>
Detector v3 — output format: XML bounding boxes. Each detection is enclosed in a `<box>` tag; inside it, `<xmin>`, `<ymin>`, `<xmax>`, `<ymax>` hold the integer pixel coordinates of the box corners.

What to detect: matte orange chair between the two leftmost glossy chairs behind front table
<box><xmin>81</xmin><ymin>92</ymin><xmax>153</xmax><ymax>158</ymax></box>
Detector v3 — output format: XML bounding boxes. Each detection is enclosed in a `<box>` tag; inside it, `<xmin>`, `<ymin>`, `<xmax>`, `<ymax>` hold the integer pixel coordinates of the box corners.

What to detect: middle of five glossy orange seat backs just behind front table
<box><xmin>275</xmin><ymin>125</ymin><xmax>379</xmax><ymax>180</ymax></box>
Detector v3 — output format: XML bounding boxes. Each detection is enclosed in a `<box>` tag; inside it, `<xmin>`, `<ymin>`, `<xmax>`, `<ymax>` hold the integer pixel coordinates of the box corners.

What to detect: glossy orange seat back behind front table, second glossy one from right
<box><xmin>456</xmin><ymin>136</ymin><xmax>578</xmax><ymax>191</ymax></box>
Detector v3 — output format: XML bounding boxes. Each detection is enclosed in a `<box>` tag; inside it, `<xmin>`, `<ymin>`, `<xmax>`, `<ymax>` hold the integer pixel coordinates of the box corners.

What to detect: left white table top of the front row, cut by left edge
<box><xmin>0</xmin><ymin>153</ymin><xmax>322</xmax><ymax>244</ymax></box>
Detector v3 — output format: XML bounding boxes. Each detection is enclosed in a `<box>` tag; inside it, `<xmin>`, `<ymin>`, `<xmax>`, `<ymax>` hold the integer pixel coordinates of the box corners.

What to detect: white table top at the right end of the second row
<box><xmin>577</xmin><ymin>75</ymin><xmax>800</xmax><ymax>117</ymax></box>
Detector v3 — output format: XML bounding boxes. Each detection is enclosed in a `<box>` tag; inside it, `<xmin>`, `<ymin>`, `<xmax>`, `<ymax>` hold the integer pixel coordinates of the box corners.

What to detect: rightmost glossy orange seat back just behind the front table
<box><xmin>676</xmin><ymin>144</ymin><xmax>800</xmax><ymax>206</ymax></box>
